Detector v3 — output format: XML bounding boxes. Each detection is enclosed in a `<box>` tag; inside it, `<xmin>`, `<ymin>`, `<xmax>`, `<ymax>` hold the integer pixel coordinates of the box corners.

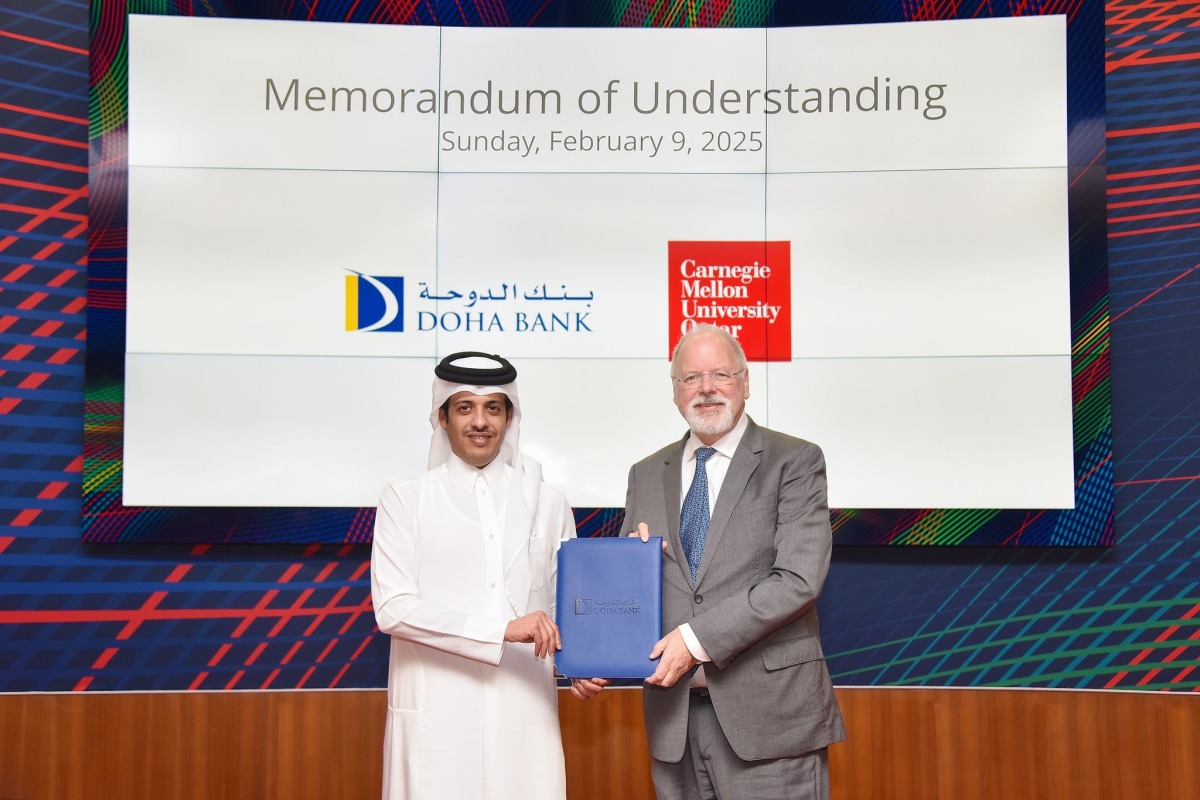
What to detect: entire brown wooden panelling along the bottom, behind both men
<box><xmin>0</xmin><ymin>688</ymin><xmax>1200</xmax><ymax>800</ymax></box>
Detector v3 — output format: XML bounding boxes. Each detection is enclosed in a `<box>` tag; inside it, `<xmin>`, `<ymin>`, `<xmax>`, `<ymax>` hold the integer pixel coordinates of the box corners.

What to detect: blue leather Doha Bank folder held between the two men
<box><xmin>554</xmin><ymin>536</ymin><xmax>662</xmax><ymax>678</ymax></box>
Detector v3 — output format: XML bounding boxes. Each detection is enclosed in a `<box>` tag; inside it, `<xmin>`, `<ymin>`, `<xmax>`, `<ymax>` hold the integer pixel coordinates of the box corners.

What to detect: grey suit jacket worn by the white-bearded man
<box><xmin>625</xmin><ymin>420</ymin><xmax>846</xmax><ymax>762</ymax></box>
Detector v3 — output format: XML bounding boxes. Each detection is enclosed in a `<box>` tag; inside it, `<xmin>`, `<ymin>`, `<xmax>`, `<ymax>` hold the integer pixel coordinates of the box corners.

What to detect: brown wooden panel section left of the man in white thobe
<box><xmin>0</xmin><ymin>691</ymin><xmax>386</xmax><ymax>800</ymax></box>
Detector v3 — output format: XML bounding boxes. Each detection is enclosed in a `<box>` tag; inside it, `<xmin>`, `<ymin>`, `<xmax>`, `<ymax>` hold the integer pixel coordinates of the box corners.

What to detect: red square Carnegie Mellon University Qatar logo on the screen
<box><xmin>667</xmin><ymin>241</ymin><xmax>792</xmax><ymax>361</ymax></box>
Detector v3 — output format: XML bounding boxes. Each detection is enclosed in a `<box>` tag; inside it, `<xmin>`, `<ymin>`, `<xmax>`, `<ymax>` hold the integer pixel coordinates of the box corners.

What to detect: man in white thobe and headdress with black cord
<box><xmin>371</xmin><ymin>353</ymin><xmax>575</xmax><ymax>800</ymax></box>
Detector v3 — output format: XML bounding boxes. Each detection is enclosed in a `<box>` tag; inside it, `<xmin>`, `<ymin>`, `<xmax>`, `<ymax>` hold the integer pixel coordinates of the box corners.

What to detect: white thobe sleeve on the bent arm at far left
<box><xmin>371</xmin><ymin>486</ymin><xmax>508</xmax><ymax>664</ymax></box>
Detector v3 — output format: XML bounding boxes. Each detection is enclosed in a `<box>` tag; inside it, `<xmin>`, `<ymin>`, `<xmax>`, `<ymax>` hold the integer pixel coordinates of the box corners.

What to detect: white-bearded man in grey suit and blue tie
<box><xmin>625</xmin><ymin>325</ymin><xmax>846</xmax><ymax>800</ymax></box>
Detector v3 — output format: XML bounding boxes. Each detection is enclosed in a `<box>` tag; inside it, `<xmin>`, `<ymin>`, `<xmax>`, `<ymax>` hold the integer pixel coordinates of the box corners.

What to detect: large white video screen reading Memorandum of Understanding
<box><xmin>85</xmin><ymin>4</ymin><xmax>1111</xmax><ymax>543</ymax></box>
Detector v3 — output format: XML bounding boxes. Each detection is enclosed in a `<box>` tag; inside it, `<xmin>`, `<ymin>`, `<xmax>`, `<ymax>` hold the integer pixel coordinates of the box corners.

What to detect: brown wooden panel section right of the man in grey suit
<box><xmin>829</xmin><ymin>688</ymin><xmax>1200</xmax><ymax>800</ymax></box>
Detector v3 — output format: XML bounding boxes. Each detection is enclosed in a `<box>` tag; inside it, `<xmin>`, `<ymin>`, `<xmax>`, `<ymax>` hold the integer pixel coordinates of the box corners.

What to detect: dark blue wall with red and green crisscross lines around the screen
<box><xmin>0</xmin><ymin>0</ymin><xmax>1200</xmax><ymax>692</ymax></box>
